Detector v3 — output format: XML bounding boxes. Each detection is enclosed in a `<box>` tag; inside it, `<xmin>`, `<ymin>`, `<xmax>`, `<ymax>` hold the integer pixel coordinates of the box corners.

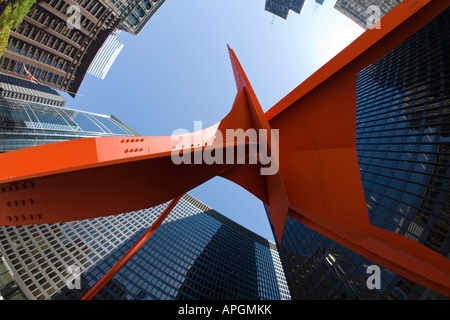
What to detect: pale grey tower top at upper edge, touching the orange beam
<box><xmin>334</xmin><ymin>0</ymin><xmax>402</xmax><ymax>30</ymax></box>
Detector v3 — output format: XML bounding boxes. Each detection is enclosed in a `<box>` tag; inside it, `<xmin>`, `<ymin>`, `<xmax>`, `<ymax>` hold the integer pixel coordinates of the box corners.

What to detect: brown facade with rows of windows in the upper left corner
<box><xmin>0</xmin><ymin>0</ymin><xmax>120</xmax><ymax>96</ymax></box>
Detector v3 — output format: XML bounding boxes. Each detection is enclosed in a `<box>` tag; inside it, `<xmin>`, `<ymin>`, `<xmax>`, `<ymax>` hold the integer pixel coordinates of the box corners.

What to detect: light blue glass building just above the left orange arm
<box><xmin>0</xmin><ymin>97</ymin><xmax>135</xmax><ymax>153</ymax></box>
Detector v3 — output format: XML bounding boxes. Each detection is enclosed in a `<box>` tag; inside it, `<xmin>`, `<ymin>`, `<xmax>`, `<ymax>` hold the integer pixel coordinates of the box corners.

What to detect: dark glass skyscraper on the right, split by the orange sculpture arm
<box><xmin>279</xmin><ymin>9</ymin><xmax>450</xmax><ymax>299</ymax></box>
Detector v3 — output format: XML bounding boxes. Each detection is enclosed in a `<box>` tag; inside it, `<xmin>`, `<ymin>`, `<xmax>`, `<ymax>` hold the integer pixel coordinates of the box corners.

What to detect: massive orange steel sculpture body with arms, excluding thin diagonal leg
<box><xmin>0</xmin><ymin>0</ymin><xmax>450</xmax><ymax>296</ymax></box>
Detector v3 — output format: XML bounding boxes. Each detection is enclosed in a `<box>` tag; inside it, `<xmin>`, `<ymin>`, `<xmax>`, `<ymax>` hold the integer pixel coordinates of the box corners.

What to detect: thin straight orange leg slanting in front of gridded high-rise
<box><xmin>81</xmin><ymin>196</ymin><xmax>182</xmax><ymax>300</ymax></box>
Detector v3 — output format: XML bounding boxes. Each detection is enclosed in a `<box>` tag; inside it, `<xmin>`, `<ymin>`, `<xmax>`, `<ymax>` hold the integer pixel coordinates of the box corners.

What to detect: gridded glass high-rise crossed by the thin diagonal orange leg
<box><xmin>0</xmin><ymin>194</ymin><xmax>290</xmax><ymax>300</ymax></box>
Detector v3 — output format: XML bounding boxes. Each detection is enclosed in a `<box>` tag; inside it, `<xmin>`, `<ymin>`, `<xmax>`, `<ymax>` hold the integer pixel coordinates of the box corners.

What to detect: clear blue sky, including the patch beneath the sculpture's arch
<box><xmin>59</xmin><ymin>0</ymin><xmax>363</xmax><ymax>241</ymax></box>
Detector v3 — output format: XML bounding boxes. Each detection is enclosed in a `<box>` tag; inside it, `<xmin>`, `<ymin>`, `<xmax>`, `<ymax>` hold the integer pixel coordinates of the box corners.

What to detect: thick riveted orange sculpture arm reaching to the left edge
<box><xmin>0</xmin><ymin>90</ymin><xmax>268</xmax><ymax>225</ymax></box>
